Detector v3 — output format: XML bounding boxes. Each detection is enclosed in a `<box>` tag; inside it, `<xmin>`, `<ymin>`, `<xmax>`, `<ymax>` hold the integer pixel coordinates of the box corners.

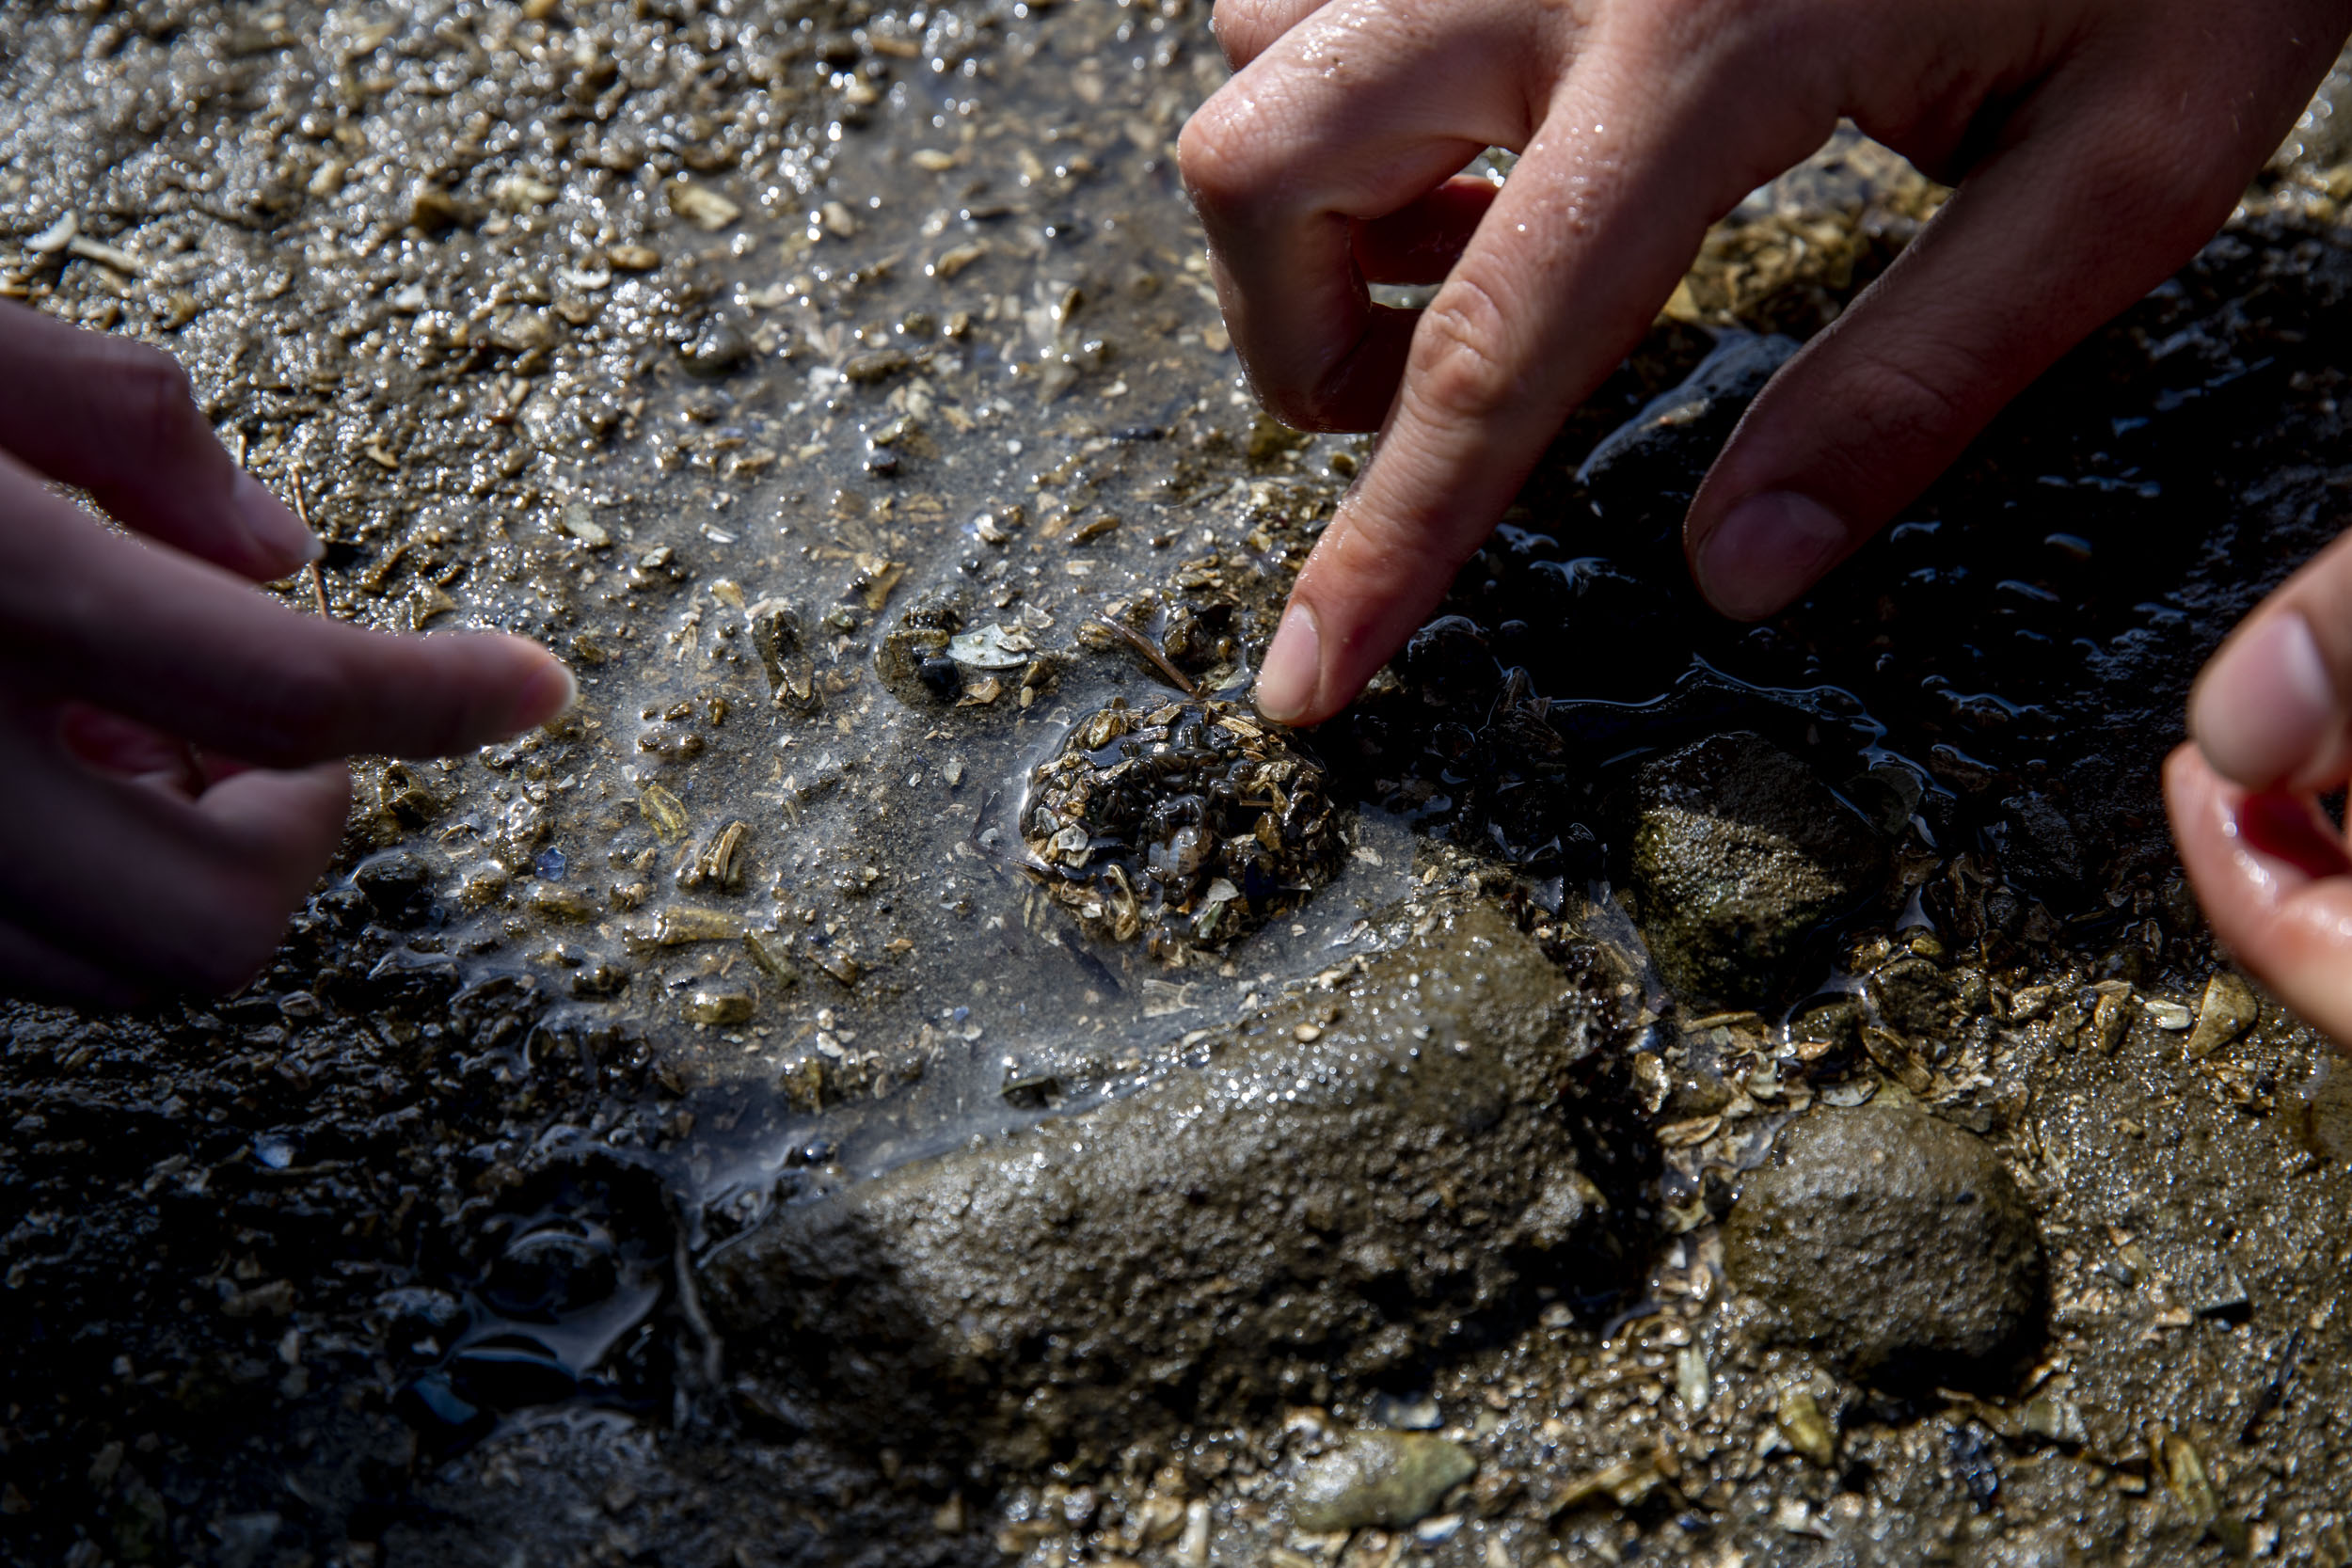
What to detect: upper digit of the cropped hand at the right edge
<box><xmin>2190</xmin><ymin>533</ymin><xmax>2352</xmax><ymax>792</ymax></box>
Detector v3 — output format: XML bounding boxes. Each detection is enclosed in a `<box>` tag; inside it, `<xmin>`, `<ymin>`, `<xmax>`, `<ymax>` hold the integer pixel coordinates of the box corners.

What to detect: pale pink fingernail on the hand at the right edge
<box><xmin>2190</xmin><ymin>609</ymin><xmax>2338</xmax><ymax>790</ymax></box>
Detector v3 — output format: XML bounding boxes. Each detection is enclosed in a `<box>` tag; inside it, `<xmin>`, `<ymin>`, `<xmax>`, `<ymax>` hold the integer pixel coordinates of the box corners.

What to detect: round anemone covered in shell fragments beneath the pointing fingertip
<box><xmin>1021</xmin><ymin>698</ymin><xmax>1348</xmax><ymax>964</ymax></box>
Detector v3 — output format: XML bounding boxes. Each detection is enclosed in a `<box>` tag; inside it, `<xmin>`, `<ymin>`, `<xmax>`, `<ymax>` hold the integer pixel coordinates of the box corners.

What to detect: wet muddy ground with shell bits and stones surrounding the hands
<box><xmin>0</xmin><ymin>0</ymin><xmax>2352</xmax><ymax>1568</ymax></box>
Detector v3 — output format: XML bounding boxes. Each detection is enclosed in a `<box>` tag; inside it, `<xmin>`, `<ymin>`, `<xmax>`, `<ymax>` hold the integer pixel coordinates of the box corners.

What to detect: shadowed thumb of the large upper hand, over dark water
<box><xmin>1684</xmin><ymin>62</ymin><xmax>2272</xmax><ymax>621</ymax></box>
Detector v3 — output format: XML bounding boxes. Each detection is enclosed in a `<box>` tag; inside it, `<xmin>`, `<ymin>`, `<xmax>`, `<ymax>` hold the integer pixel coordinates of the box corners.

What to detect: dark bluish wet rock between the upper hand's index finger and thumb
<box><xmin>1576</xmin><ymin>331</ymin><xmax>1797</xmax><ymax>538</ymax></box>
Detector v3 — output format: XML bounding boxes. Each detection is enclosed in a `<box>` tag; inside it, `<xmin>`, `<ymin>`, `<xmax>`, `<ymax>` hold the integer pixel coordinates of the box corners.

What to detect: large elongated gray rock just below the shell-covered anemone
<box><xmin>704</xmin><ymin>910</ymin><xmax>1613</xmax><ymax>1463</ymax></box>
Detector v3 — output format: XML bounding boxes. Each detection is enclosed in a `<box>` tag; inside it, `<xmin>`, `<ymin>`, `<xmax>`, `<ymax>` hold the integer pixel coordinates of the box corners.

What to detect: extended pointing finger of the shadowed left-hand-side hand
<box><xmin>0</xmin><ymin>458</ymin><xmax>574</xmax><ymax>768</ymax></box>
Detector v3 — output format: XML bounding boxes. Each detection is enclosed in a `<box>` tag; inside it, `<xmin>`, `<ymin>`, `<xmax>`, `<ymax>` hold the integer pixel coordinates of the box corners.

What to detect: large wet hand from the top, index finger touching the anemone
<box><xmin>1181</xmin><ymin>0</ymin><xmax>2352</xmax><ymax>721</ymax></box>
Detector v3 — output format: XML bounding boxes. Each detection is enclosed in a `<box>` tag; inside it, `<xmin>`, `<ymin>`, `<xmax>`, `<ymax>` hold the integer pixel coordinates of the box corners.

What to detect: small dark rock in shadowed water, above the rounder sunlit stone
<box><xmin>1628</xmin><ymin>731</ymin><xmax>1884</xmax><ymax>1004</ymax></box>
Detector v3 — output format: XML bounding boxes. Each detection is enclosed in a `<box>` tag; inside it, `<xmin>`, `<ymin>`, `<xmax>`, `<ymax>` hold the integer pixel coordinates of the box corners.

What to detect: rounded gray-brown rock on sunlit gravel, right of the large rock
<box><xmin>1724</xmin><ymin>1096</ymin><xmax>2044</xmax><ymax>1380</ymax></box>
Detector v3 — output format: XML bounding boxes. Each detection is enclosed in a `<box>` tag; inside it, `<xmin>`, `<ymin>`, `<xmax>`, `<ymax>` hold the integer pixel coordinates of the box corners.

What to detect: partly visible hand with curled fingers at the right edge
<box><xmin>2164</xmin><ymin>536</ymin><xmax>2352</xmax><ymax>1041</ymax></box>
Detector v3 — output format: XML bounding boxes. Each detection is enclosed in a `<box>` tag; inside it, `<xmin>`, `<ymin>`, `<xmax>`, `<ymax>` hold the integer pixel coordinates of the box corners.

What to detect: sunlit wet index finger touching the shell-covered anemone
<box><xmin>1256</xmin><ymin>40</ymin><xmax>1830</xmax><ymax>724</ymax></box>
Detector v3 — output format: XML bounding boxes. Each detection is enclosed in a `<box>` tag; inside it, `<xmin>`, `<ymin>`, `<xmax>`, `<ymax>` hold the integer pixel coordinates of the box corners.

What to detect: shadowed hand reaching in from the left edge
<box><xmin>0</xmin><ymin>306</ymin><xmax>572</xmax><ymax>1004</ymax></box>
